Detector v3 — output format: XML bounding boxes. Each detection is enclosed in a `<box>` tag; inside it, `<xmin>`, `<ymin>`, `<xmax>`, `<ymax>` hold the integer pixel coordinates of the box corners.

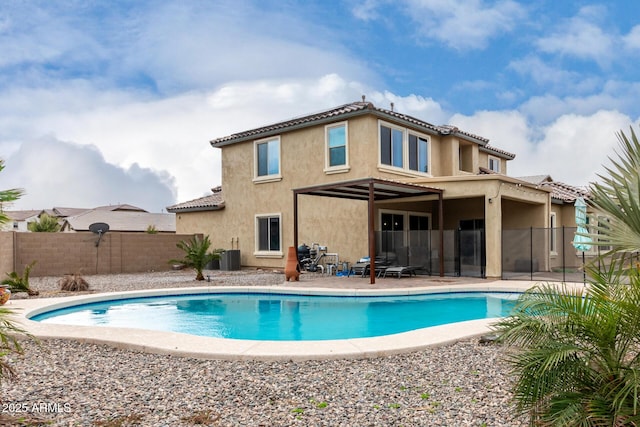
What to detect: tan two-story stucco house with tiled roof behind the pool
<box><xmin>168</xmin><ymin>101</ymin><xmax>596</xmax><ymax>277</ymax></box>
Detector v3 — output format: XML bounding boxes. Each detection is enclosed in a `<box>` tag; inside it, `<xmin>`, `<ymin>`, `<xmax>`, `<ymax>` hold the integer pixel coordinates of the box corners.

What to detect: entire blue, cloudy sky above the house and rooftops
<box><xmin>0</xmin><ymin>0</ymin><xmax>640</xmax><ymax>212</ymax></box>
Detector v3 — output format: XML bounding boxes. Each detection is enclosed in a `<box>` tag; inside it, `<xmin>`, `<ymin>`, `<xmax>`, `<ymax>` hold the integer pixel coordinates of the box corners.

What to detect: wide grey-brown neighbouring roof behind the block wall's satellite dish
<box><xmin>62</xmin><ymin>209</ymin><xmax>176</xmax><ymax>233</ymax></box>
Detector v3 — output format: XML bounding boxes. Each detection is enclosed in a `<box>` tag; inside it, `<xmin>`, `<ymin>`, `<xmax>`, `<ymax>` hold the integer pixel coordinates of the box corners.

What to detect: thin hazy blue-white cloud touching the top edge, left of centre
<box><xmin>117</xmin><ymin>2</ymin><xmax>375</xmax><ymax>93</ymax></box>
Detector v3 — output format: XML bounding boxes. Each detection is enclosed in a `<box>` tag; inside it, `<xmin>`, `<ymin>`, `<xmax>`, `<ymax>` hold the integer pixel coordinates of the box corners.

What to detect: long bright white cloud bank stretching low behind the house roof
<box><xmin>0</xmin><ymin>69</ymin><xmax>631</xmax><ymax>211</ymax></box>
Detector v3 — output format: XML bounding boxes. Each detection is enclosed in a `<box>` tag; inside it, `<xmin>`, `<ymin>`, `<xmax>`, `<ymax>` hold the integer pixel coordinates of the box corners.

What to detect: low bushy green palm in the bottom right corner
<box><xmin>494</xmin><ymin>260</ymin><xmax>640</xmax><ymax>427</ymax></box>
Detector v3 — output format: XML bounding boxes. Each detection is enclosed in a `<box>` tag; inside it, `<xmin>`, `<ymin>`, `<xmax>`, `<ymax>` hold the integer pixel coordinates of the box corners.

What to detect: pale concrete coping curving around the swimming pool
<box><xmin>4</xmin><ymin>281</ymin><xmax>534</xmax><ymax>360</ymax></box>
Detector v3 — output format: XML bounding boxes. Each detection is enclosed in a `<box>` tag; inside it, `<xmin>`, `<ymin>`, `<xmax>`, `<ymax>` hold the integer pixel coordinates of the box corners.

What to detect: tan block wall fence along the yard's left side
<box><xmin>0</xmin><ymin>231</ymin><xmax>200</xmax><ymax>278</ymax></box>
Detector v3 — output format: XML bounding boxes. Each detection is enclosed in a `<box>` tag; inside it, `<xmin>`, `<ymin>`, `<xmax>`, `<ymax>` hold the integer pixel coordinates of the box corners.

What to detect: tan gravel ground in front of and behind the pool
<box><xmin>0</xmin><ymin>270</ymin><xmax>527</xmax><ymax>426</ymax></box>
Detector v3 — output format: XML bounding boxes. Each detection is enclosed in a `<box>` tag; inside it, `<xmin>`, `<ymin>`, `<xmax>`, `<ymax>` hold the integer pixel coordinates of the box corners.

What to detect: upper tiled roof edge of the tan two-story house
<box><xmin>210</xmin><ymin>101</ymin><xmax>515</xmax><ymax>159</ymax></box>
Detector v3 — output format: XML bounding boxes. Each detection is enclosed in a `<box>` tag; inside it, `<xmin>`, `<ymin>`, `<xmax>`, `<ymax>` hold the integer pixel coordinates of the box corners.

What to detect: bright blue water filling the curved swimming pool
<box><xmin>31</xmin><ymin>292</ymin><xmax>518</xmax><ymax>341</ymax></box>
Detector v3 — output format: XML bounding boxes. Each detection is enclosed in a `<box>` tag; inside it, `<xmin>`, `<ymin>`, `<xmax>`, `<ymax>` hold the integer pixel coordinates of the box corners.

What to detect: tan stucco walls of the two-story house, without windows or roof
<box><xmin>188</xmin><ymin>116</ymin><xmax>549</xmax><ymax>277</ymax></box>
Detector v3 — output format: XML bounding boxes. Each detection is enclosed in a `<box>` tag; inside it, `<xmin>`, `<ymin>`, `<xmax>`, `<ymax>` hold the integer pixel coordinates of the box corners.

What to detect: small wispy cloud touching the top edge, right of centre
<box><xmin>406</xmin><ymin>0</ymin><xmax>526</xmax><ymax>50</ymax></box>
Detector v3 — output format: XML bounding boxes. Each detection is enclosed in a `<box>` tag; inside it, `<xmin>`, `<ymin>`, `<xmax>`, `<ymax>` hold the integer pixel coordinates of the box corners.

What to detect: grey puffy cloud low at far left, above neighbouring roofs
<box><xmin>2</xmin><ymin>137</ymin><xmax>175</xmax><ymax>212</ymax></box>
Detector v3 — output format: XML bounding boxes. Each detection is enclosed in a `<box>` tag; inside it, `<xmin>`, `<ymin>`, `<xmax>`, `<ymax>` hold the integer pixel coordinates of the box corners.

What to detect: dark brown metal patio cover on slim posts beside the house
<box><xmin>293</xmin><ymin>178</ymin><xmax>444</xmax><ymax>284</ymax></box>
